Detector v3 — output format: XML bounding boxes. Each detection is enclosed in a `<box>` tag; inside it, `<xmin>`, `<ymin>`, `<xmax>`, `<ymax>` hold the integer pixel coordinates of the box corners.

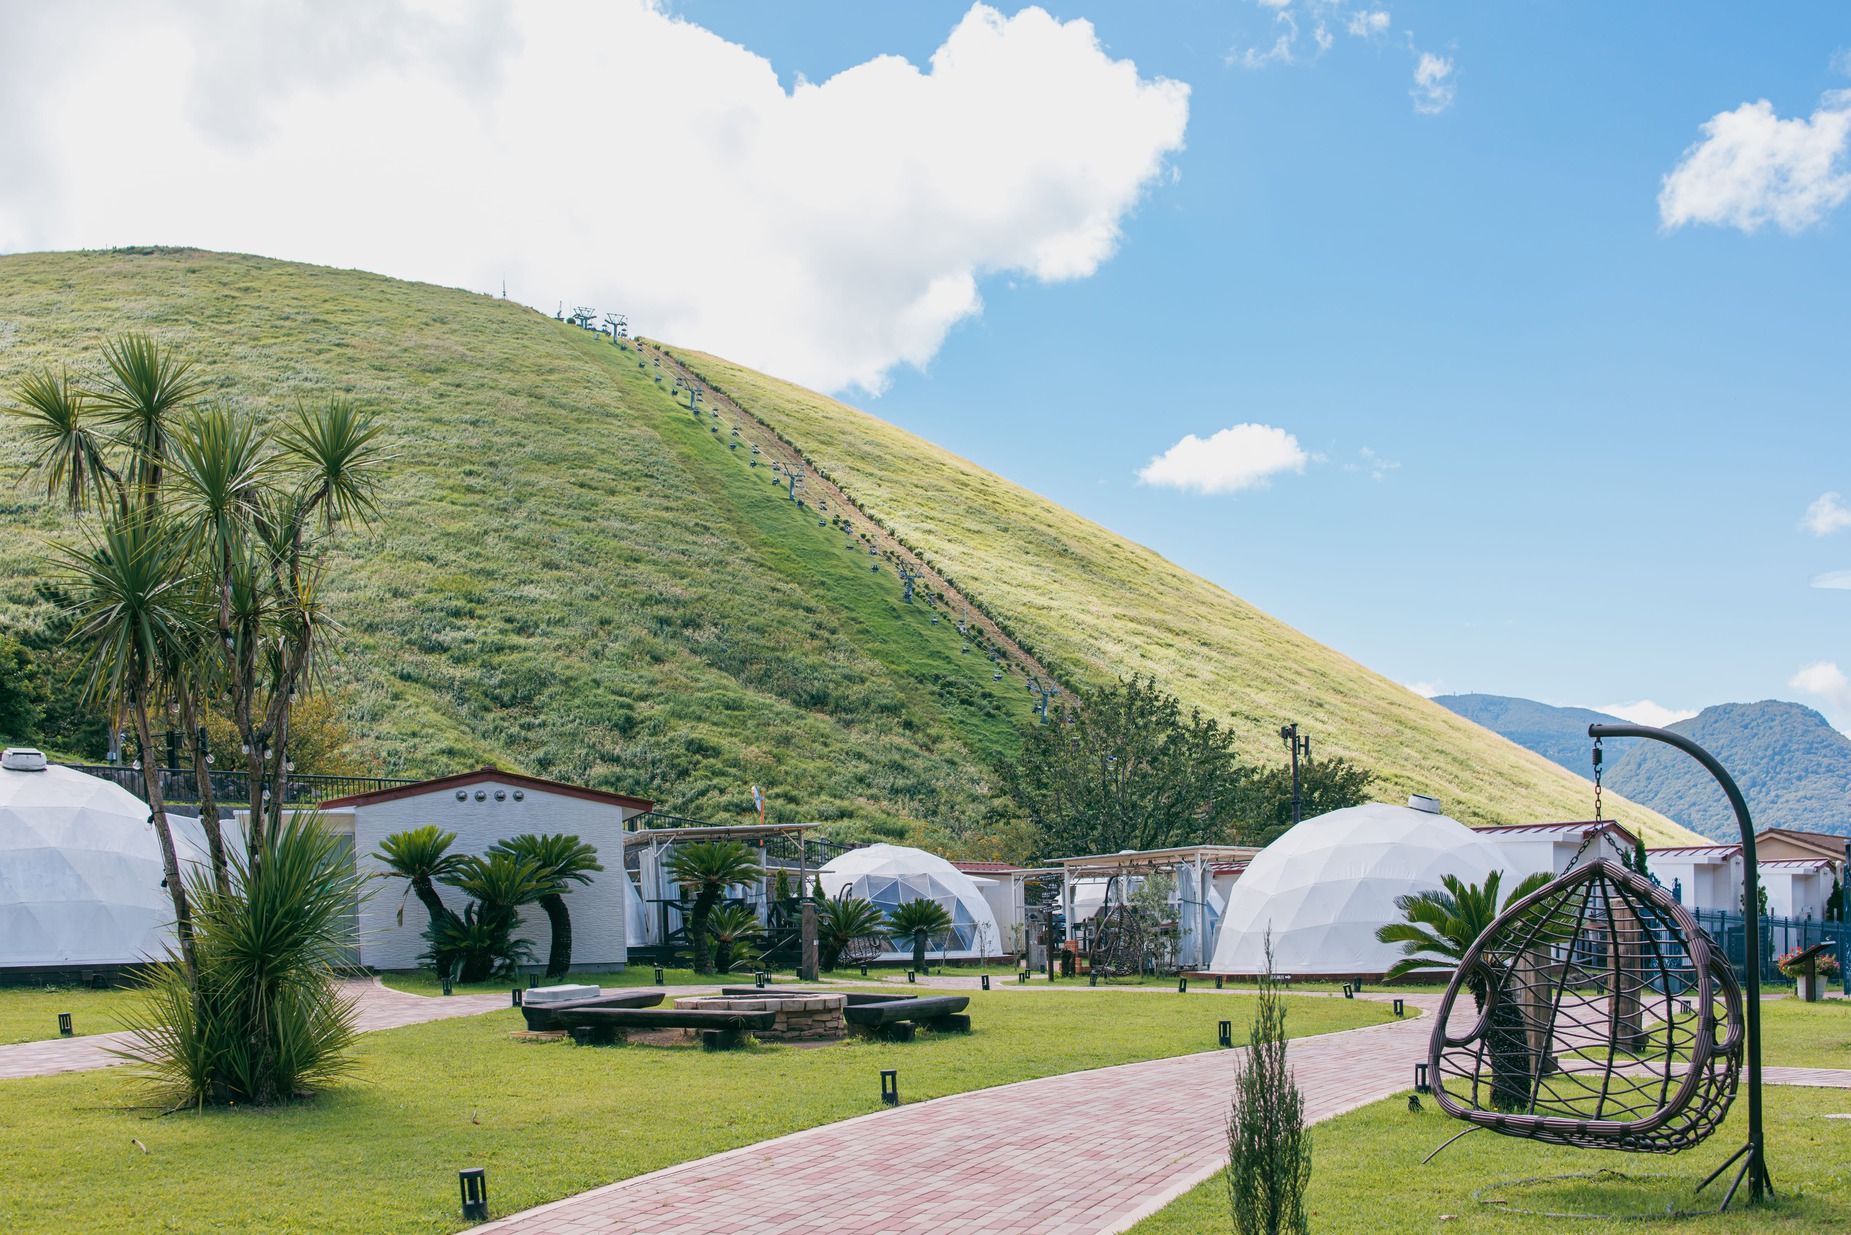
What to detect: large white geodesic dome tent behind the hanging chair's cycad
<box><xmin>1209</xmin><ymin>798</ymin><xmax>1503</xmax><ymax>976</ymax></box>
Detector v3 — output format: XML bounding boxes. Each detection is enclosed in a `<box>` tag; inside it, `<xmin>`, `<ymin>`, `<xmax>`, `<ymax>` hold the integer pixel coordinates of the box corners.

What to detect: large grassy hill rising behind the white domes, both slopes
<box><xmin>0</xmin><ymin>250</ymin><xmax>1702</xmax><ymax>852</ymax></box>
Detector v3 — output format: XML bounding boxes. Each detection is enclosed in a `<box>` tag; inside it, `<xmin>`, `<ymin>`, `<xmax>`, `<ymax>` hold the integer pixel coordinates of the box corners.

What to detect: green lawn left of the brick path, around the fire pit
<box><xmin>0</xmin><ymin>991</ymin><xmax>1386</xmax><ymax>1233</ymax></box>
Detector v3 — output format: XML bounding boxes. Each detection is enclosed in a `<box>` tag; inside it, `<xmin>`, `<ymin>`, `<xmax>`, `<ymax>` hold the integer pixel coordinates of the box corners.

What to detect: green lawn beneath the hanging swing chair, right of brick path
<box><xmin>1131</xmin><ymin>1087</ymin><xmax>1851</xmax><ymax>1235</ymax></box>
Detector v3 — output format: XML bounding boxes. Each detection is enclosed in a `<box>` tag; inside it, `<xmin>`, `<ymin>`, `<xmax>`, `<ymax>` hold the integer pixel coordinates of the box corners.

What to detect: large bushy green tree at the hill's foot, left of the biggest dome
<box><xmin>1001</xmin><ymin>676</ymin><xmax>1246</xmax><ymax>855</ymax></box>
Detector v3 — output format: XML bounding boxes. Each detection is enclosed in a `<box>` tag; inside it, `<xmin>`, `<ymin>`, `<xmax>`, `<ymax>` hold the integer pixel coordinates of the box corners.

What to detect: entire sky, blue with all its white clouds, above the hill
<box><xmin>0</xmin><ymin>0</ymin><xmax>1851</xmax><ymax>726</ymax></box>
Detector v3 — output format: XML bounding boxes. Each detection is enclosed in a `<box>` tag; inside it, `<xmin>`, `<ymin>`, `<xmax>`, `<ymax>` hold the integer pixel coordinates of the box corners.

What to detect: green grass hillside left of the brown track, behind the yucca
<box><xmin>0</xmin><ymin>250</ymin><xmax>1029</xmax><ymax>852</ymax></box>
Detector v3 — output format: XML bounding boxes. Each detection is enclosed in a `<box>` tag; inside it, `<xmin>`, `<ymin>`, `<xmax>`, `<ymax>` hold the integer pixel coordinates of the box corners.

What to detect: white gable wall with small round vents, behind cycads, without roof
<box><xmin>354</xmin><ymin>780</ymin><xmax>627</xmax><ymax>970</ymax></box>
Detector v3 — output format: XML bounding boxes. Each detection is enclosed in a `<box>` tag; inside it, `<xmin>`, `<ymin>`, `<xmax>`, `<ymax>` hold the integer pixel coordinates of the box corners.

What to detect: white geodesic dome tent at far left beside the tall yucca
<box><xmin>0</xmin><ymin>765</ymin><xmax>202</xmax><ymax>968</ymax></box>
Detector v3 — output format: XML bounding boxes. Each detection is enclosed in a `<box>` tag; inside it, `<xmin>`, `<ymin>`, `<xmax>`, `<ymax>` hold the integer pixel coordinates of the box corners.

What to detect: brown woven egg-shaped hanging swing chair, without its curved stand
<box><xmin>1427</xmin><ymin>859</ymin><xmax>1745</xmax><ymax>1154</ymax></box>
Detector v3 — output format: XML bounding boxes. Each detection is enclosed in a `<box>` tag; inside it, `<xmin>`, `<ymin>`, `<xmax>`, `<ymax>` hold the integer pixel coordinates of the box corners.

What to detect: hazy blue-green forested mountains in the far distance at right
<box><xmin>1435</xmin><ymin>694</ymin><xmax>1851</xmax><ymax>841</ymax></box>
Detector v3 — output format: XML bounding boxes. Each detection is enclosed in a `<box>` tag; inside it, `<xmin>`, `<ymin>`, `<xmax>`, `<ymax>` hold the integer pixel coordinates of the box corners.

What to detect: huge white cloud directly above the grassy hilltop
<box><xmin>0</xmin><ymin>0</ymin><xmax>1188</xmax><ymax>389</ymax></box>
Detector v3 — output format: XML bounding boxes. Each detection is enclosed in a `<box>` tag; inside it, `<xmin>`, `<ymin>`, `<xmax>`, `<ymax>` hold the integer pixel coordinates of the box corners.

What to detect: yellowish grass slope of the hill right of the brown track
<box><xmin>666</xmin><ymin>348</ymin><xmax>1694</xmax><ymax>844</ymax></box>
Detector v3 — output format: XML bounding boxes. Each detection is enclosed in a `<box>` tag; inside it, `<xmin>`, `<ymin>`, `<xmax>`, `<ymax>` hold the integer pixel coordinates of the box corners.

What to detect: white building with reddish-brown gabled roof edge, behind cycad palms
<box><xmin>320</xmin><ymin>767</ymin><xmax>655</xmax><ymax>972</ymax></box>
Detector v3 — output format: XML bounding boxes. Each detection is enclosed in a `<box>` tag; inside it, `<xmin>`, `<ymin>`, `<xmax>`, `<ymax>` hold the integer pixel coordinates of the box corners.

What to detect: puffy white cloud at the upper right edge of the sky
<box><xmin>1658</xmin><ymin>91</ymin><xmax>1851</xmax><ymax>231</ymax></box>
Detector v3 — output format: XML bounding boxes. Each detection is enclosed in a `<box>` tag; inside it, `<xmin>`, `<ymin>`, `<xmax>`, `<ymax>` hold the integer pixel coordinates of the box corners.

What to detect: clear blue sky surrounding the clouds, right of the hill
<box><xmin>679</xmin><ymin>0</ymin><xmax>1851</xmax><ymax>724</ymax></box>
